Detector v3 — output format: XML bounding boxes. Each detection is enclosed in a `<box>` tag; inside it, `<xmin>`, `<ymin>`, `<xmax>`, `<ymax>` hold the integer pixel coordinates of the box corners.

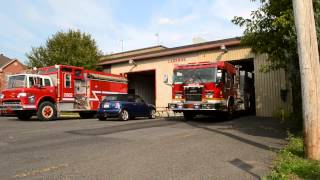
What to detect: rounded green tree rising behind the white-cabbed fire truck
<box><xmin>26</xmin><ymin>30</ymin><xmax>101</xmax><ymax>69</ymax></box>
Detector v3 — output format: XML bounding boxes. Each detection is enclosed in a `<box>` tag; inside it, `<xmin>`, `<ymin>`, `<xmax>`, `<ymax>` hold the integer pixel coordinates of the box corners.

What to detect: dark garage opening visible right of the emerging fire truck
<box><xmin>229</xmin><ymin>59</ymin><xmax>256</xmax><ymax>115</ymax></box>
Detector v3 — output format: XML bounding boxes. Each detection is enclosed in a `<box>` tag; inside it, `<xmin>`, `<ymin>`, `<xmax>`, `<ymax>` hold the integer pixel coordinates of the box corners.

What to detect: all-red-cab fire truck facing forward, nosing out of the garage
<box><xmin>168</xmin><ymin>62</ymin><xmax>250</xmax><ymax>120</ymax></box>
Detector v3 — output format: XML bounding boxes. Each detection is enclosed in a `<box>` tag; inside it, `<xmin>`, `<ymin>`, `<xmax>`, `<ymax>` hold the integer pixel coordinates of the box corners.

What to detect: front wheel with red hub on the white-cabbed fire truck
<box><xmin>37</xmin><ymin>101</ymin><xmax>57</xmax><ymax>121</ymax></box>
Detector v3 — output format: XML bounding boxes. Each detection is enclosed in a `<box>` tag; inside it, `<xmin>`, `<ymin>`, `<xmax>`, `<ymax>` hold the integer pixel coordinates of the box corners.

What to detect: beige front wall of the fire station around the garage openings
<box><xmin>111</xmin><ymin>47</ymin><xmax>287</xmax><ymax>116</ymax></box>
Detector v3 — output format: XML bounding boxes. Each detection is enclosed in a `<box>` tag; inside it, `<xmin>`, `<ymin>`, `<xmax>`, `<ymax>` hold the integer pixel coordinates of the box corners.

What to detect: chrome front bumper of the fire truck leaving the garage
<box><xmin>168</xmin><ymin>100</ymin><xmax>227</xmax><ymax>112</ymax></box>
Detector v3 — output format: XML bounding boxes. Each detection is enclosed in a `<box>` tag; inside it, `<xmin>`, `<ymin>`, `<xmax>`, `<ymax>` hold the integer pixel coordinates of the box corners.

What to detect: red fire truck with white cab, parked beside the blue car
<box><xmin>0</xmin><ymin>65</ymin><xmax>128</xmax><ymax>120</ymax></box>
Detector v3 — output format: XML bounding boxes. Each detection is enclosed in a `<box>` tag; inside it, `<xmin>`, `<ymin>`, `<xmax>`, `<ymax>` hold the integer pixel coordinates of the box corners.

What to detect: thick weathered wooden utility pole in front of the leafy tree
<box><xmin>293</xmin><ymin>0</ymin><xmax>320</xmax><ymax>160</ymax></box>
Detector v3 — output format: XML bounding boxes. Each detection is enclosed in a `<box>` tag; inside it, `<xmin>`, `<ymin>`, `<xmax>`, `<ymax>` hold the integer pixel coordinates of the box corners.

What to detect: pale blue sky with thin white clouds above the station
<box><xmin>0</xmin><ymin>0</ymin><xmax>259</xmax><ymax>63</ymax></box>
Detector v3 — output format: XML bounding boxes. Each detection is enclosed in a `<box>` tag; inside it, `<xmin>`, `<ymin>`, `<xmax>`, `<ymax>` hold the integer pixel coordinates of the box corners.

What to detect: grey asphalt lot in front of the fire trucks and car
<box><xmin>0</xmin><ymin>117</ymin><xmax>285</xmax><ymax>180</ymax></box>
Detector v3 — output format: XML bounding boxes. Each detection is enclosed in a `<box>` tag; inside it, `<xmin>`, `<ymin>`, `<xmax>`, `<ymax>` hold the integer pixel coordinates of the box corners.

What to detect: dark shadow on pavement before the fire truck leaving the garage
<box><xmin>178</xmin><ymin>116</ymin><xmax>286</xmax><ymax>151</ymax></box>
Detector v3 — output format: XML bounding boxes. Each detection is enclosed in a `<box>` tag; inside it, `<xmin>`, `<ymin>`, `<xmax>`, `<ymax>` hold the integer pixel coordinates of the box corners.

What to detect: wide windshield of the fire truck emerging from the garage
<box><xmin>173</xmin><ymin>68</ymin><xmax>217</xmax><ymax>84</ymax></box>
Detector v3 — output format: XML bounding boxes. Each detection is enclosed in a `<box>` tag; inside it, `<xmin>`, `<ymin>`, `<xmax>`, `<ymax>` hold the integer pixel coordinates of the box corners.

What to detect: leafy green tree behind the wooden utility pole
<box><xmin>232</xmin><ymin>0</ymin><xmax>320</xmax><ymax>128</ymax></box>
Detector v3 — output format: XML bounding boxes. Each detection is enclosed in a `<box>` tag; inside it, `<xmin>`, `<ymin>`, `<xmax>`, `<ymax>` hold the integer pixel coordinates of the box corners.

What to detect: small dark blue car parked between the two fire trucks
<box><xmin>97</xmin><ymin>94</ymin><xmax>156</xmax><ymax>121</ymax></box>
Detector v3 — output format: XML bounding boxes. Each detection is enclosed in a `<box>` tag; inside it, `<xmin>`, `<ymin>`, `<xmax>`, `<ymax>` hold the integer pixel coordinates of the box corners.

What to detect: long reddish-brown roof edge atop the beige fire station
<box><xmin>99</xmin><ymin>37</ymin><xmax>240</xmax><ymax>65</ymax></box>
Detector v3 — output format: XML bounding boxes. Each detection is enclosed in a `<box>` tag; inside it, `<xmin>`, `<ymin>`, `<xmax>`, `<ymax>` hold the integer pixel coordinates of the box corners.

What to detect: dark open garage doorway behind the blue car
<box><xmin>127</xmin><ymin>70</ymin><xmax>156</xmax><ymax>105</ymax></box>
